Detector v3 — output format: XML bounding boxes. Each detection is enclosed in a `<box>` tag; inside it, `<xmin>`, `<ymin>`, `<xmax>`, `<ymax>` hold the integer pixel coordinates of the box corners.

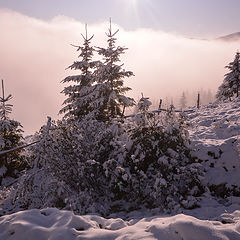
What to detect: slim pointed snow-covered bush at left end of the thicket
<box><xmin>10</xmin><ymin>118</ymin><xmax>67</xmax><ymax>209</ymax></box>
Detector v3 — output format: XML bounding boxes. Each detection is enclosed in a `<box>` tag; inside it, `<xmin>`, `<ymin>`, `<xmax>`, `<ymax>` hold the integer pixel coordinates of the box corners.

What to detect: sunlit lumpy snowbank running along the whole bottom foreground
<box><xmin>0</xmin><ymin>208</ymin><xmax>240</xmax><ymax>240</ymax></box>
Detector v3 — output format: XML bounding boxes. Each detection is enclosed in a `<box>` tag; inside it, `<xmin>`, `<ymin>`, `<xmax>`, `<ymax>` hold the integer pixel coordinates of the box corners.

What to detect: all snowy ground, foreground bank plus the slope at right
<box><xmin>0</xmin><ymin>99</ymin><xmax>240</xmax><ymax>240</ymax></box>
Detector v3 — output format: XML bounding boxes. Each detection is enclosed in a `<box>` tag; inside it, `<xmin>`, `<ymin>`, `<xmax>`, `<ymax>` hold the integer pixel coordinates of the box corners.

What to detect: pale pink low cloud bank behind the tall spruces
<box><xmin>0</xmin><ymin>9</ymin><xmax>239</xmax><ymax>134</ymax></box>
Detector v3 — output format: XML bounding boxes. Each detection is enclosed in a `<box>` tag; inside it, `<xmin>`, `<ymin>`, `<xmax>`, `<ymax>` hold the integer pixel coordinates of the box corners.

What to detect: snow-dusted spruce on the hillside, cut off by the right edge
<box><xmin>216</xmin><ymin>52</ymin><xmax>240</xmax><ymax>100</ymax></box>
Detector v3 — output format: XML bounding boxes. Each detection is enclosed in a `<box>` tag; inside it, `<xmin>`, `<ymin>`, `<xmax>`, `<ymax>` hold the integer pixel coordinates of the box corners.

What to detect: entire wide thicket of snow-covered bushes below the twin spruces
<box><xmin>7</xmin><ymin>107</ymin><xmax>204</xmax><ymax>215</ymax></box>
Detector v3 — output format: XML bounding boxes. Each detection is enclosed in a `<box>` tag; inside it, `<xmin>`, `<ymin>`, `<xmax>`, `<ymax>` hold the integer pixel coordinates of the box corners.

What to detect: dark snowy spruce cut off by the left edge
<box><xmin>0</xmin><ymin>80</ymin><xmax>24</xmax><ymax>182</ymax></box>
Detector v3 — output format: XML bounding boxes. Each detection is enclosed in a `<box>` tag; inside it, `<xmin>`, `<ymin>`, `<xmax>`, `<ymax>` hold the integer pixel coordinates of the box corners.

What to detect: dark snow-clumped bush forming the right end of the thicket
<box><xmin>123</xmin><ymin>99</ymin><xmax>204</xmax><ymax>212</ymax></box>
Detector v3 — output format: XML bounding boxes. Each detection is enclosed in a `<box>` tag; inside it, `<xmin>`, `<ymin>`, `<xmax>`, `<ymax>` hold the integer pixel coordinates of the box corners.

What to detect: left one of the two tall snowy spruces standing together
<box><xmin>60</xmin><ymin>25</ymin><xmax>99</xmax><ymax>119</ymax></box>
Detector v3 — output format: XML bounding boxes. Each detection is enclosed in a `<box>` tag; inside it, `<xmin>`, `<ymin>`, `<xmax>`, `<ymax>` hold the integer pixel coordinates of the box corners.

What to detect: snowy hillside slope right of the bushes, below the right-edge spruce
<box><xmin>189</xmin><ymin>100</ymin><xmax>240</xmax><ymax>197</ymax></box>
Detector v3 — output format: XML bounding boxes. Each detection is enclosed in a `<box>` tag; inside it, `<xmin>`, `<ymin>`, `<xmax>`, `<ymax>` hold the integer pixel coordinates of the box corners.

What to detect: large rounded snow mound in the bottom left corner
<box><xmin>0</xmin><ymin>208</ymin><xmax>98</xmax><ymax>240</ymax></box>
